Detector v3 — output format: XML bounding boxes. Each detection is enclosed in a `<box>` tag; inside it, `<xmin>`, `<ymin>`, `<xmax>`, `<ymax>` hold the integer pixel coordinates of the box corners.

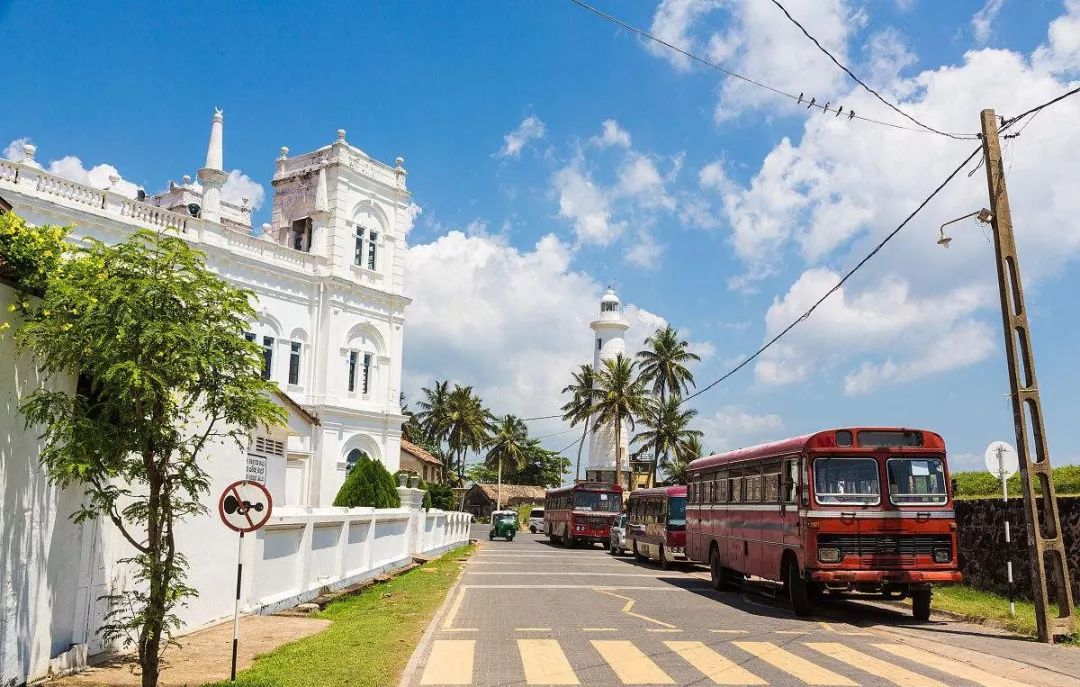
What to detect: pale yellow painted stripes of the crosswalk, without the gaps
<box><xmin>419</xmin><ymin>638</ymin><xmax>1028</xmax><ymax>687</ymax></box>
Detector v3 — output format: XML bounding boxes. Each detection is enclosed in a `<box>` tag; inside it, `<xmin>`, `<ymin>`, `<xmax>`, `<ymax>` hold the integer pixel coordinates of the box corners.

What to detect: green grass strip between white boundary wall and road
<box><xmin>207</xmin><ymin>545</ymin><xmax>475</xmax><ymax>687</ymax></box>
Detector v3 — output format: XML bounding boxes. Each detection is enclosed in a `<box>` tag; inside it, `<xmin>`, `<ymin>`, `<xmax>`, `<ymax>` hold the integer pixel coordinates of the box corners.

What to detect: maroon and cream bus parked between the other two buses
<box><xmin>626</xmin><ymin>486</ymin><xmax>688</xmax><ymax>570</ymax></box>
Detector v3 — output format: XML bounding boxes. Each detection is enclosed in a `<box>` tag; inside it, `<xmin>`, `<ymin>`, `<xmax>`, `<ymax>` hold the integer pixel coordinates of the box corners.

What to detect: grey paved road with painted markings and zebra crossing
<box><xmin>405</xmin><ymin>528</ymin><xmax>1080</xmax><ymax>687</ymax></box>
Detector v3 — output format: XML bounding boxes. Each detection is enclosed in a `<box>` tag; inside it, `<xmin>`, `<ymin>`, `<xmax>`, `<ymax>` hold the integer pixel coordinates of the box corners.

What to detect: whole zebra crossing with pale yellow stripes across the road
<box><xmin>419</xmin><ymin>637</ymin><xmax>1027</xmax><ymax>687</ymax></box>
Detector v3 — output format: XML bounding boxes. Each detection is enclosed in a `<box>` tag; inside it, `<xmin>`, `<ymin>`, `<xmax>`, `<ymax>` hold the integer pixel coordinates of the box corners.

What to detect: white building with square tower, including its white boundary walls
<box><xmin>0</xmin><ymin>111</ymin><xmax>469</xmax><ymax>685</ymax></box>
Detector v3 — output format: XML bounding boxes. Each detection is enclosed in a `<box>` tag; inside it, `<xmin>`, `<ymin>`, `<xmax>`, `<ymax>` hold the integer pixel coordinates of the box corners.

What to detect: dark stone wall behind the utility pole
<box><xmin>956</xmin><ymin>496</ymin><xmax>1080</xmax><ymax>598</ymax></box>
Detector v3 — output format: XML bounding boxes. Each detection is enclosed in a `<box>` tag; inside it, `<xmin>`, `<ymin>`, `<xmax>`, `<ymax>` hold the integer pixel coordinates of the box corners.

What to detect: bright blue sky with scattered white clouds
<box><xmin>0</xmin><ymin>0</ymin><xmax>1080</xmax><ymax>473</ymax></box>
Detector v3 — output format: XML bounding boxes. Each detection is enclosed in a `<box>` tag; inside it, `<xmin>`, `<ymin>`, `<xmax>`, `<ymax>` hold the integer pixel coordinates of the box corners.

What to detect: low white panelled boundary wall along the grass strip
<box><xmin>245</xmin><ymin>489</ymin><xmax>472</xmax><ymax>615</ymax></box>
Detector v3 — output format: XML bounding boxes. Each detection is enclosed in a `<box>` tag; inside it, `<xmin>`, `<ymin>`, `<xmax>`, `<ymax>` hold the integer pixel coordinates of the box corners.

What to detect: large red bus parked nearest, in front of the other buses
<box><xmin>687</xmin><ymin>428</ymin><xmax>961</xmax><ymax>620</ymax></box>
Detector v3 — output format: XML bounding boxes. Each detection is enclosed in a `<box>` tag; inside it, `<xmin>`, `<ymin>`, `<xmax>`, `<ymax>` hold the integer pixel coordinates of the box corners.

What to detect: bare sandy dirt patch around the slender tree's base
<box><xmin>46</xmin><ymin>616</ymin><xmax>330</xmax><ymax>687</ymax></box>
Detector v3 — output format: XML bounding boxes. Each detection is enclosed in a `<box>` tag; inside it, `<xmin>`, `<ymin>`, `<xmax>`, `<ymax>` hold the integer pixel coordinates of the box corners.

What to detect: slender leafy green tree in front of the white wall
<box><xmin>8</xmin><ymin>227</ymin><xmax>286</xmax><ymax>687</ymax></box>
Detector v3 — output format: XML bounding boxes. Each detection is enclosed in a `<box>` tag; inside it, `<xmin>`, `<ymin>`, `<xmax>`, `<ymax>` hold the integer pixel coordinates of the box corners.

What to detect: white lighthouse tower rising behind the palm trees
<box><xmin>585</xmin><ymin>287</ymin><xmax>630</xmax><ymax>483</ymax></box>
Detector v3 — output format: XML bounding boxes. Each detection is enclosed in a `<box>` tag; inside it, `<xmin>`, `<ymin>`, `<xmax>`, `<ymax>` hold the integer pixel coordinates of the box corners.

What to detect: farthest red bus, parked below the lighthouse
<box><xmin>543</xmin><ymin>482</ymin><xmax>622</xmax><ymax>547</ymax></box>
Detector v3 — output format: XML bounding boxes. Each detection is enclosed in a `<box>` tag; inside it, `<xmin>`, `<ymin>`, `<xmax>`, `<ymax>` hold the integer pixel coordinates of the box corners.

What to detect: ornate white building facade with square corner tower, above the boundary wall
<box><xmin>0</xmin><ymin>111</ymin><xmax>411</xmax><ymax>506</ymax></box>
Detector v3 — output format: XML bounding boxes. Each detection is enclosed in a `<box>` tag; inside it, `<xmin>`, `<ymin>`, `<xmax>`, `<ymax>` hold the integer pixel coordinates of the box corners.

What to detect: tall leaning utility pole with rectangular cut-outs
<box><xmin>982</xmin><ymin>110</ymin><xmax>1074</xmax><ymax>643</ymax></box>
